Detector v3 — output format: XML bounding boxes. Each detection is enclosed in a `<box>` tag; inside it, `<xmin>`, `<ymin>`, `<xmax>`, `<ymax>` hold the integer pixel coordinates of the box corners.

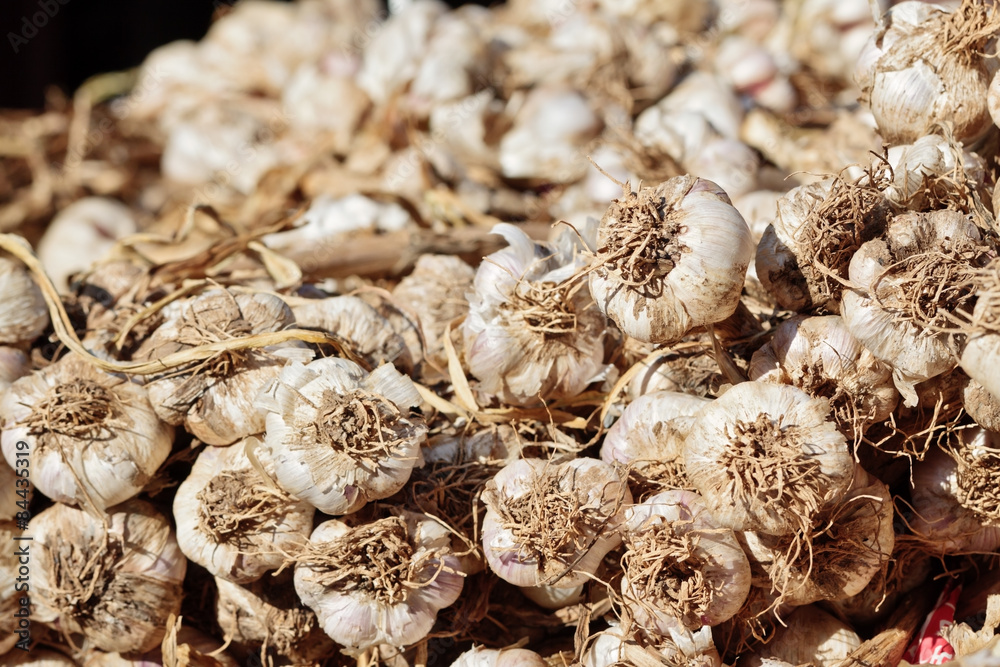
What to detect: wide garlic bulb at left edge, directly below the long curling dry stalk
<box><xmin>0</xmin><ymin>353</ymin><xmax>173</xmax><ymax>510</ymax></box>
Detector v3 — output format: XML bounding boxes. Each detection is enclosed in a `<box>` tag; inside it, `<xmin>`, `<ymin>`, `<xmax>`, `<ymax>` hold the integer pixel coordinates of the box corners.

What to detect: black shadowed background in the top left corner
<box><xmin>0</xmin><ymin>0</ymin><xmax>484</xmax><ymax>109</ymax></box>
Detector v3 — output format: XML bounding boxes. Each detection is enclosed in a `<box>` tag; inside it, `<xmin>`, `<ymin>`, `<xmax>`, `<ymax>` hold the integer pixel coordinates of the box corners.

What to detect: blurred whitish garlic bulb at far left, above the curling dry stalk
<box><xmin>38</xmin><ymin>197</ymin><xmax>138</xmax><ymax>292</ymax></box>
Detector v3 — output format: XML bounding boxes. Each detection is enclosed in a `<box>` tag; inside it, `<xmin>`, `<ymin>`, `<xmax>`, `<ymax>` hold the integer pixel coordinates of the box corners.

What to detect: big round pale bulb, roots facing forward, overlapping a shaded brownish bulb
<box><xmin>684</xmin><ymin>382</ymin><xmax>854</xmax><ymax>535</ymax></box>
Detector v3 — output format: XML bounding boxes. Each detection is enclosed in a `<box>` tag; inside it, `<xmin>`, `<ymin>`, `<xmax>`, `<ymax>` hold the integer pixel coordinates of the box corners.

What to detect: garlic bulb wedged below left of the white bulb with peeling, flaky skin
<box><xmin>173</xmin><ymin>440</ymin><xmax>315</xmax><ymax>584</ymax></box>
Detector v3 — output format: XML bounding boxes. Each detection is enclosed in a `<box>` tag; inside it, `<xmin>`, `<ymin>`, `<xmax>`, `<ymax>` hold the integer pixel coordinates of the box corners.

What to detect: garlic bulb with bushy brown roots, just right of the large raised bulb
<box><xmin>754</xmin><ymin>174</ymin><xmax>888</xmax><ymax>313</ymax></box>
